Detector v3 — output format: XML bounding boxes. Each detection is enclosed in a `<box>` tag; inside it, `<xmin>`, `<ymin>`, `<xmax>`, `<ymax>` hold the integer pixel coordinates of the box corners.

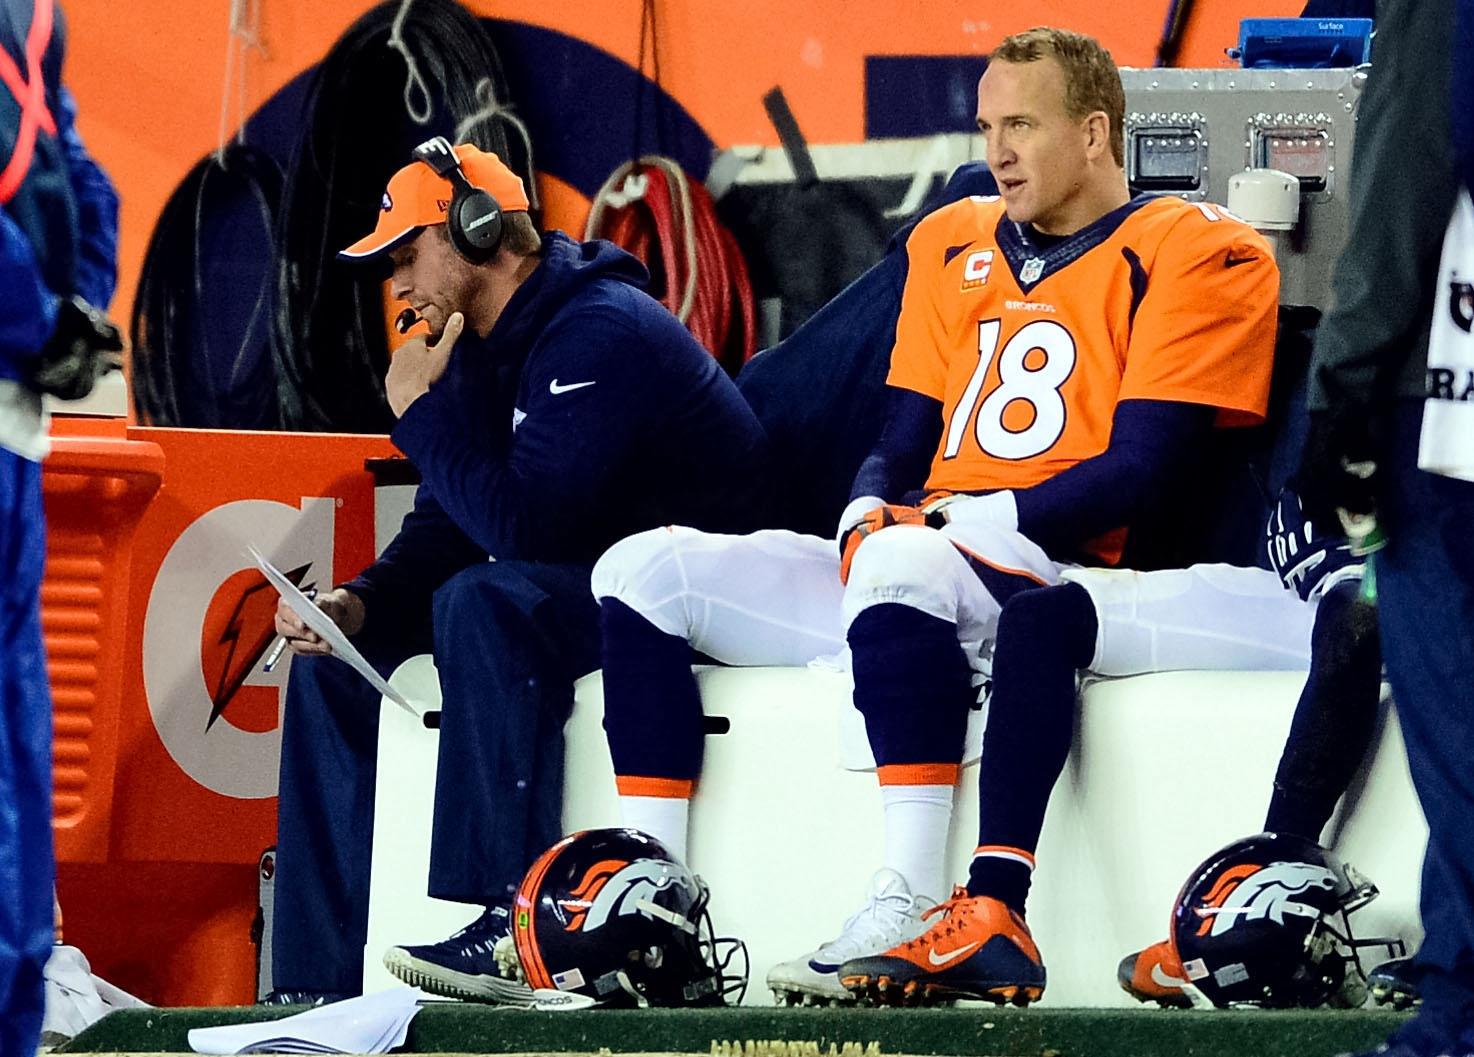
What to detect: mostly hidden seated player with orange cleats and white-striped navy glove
<box><xmin>840</xmin><ymin>491</ymin><xmax>1381</xmax><ymax>1007</ymax></box>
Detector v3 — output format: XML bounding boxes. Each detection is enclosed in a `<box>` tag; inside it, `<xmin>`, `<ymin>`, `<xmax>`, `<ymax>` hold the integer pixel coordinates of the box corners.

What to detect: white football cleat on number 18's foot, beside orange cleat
<box><xmin>768</xmin><ymin>868</ymin><xmax>933</xmax><ymax>1005</ymax></box>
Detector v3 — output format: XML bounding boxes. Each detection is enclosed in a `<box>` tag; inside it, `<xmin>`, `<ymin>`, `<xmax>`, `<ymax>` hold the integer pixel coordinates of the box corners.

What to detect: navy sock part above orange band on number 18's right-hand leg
<box><xmin>848</xmin><ymin>601</ymin><xmax>977</xmax><ymax>781</ymax></box>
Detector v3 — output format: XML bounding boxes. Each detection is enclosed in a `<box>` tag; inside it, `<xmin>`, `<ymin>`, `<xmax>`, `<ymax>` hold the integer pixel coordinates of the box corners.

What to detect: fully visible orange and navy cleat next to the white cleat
<box><xmin>839</xmin><ymin>887</ymin><xmax>1044</xmax><ymax>1005</ymax></box>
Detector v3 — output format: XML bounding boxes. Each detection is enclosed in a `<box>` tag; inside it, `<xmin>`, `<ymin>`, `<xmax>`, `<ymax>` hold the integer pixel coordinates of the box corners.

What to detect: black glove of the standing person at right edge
<box><xmin>1294</xmin><ymin>410</ymin><xmax>1380</xmax><ymax>532</ymax></box>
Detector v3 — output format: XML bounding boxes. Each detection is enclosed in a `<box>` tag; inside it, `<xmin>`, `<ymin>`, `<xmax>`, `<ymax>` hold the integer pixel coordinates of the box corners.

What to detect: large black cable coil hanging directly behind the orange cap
<box><xmin>273</xmin><ymin>0</ymin><xmax>532</xmax><ymax>433</ymax></box>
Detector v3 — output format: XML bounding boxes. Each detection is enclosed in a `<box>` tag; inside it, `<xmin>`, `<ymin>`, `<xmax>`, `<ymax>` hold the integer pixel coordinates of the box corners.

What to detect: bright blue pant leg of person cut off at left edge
<box><xmin>0</xmin><ymin>448</ymin><xmax>55</xmax><ymax>1054</ymax></box>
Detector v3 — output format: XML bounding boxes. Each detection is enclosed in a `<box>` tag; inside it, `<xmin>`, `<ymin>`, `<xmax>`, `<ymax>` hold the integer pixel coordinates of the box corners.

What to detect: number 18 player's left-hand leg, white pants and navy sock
<box><xmin>593</xmin><ymin>528</ymin><xmax>845</xmax><ymax>859</ymax></box>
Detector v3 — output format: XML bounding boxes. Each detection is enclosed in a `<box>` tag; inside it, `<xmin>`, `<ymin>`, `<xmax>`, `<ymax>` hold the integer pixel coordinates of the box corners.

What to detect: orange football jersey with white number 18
<box><xmin>887</xmin><ymin>198</ymin><xmax>1279</xmax><ymax>504</ymax></box>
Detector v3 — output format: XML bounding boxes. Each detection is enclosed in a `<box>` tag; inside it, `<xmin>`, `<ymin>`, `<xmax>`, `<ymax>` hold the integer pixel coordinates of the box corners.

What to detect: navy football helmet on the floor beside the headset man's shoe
<box><xmin>511</xmin><ymin>828</ymin><xmax>747</xmax><ymax>1005</ymax></box>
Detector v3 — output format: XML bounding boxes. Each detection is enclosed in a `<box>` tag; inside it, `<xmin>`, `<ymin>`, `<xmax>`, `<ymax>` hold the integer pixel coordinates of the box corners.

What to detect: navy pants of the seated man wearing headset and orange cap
<box><xmin>271</xmin><ymin>562</ymin><xmax>598</xmax><ymax>994</ymax></box>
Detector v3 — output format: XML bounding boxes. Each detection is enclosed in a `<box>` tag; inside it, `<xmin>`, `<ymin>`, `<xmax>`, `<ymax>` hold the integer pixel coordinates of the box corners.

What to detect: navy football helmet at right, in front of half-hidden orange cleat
<box><xmin>1172</xmin><ymin>833</ymin><xmax>1402</xmax><ymax>1008</ymax></box>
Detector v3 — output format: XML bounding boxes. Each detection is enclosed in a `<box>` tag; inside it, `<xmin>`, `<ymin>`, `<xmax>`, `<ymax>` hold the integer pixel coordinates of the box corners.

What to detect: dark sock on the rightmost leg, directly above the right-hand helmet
<box><xmin>1265</xmin><ymin>582</ymin><xmax>1381</xmax><ymax>842</ymax></box>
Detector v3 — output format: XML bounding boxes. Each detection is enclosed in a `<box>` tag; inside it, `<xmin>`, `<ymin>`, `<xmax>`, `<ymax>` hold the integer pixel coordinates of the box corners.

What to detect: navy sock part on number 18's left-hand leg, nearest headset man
<box><xmin>598</xmin><ymin>599</ymin><xmax>703</xmax><ymax>780</ymax></box>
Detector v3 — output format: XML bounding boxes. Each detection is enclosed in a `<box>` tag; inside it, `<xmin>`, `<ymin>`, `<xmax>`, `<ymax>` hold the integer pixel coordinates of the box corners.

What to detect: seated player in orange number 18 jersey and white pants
<box><xmin>594</xmin><ymin>20</ymin><xmax>1278</xmax><ymax>1000</ymax></box>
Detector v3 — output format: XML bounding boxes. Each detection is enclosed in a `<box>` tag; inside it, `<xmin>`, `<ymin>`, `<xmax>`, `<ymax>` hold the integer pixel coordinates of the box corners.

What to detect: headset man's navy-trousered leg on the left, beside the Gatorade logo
<box><xmin>271</xmin><ymin>613</ymin><xmax>429</xmax><ymax>998</ymax></box>
